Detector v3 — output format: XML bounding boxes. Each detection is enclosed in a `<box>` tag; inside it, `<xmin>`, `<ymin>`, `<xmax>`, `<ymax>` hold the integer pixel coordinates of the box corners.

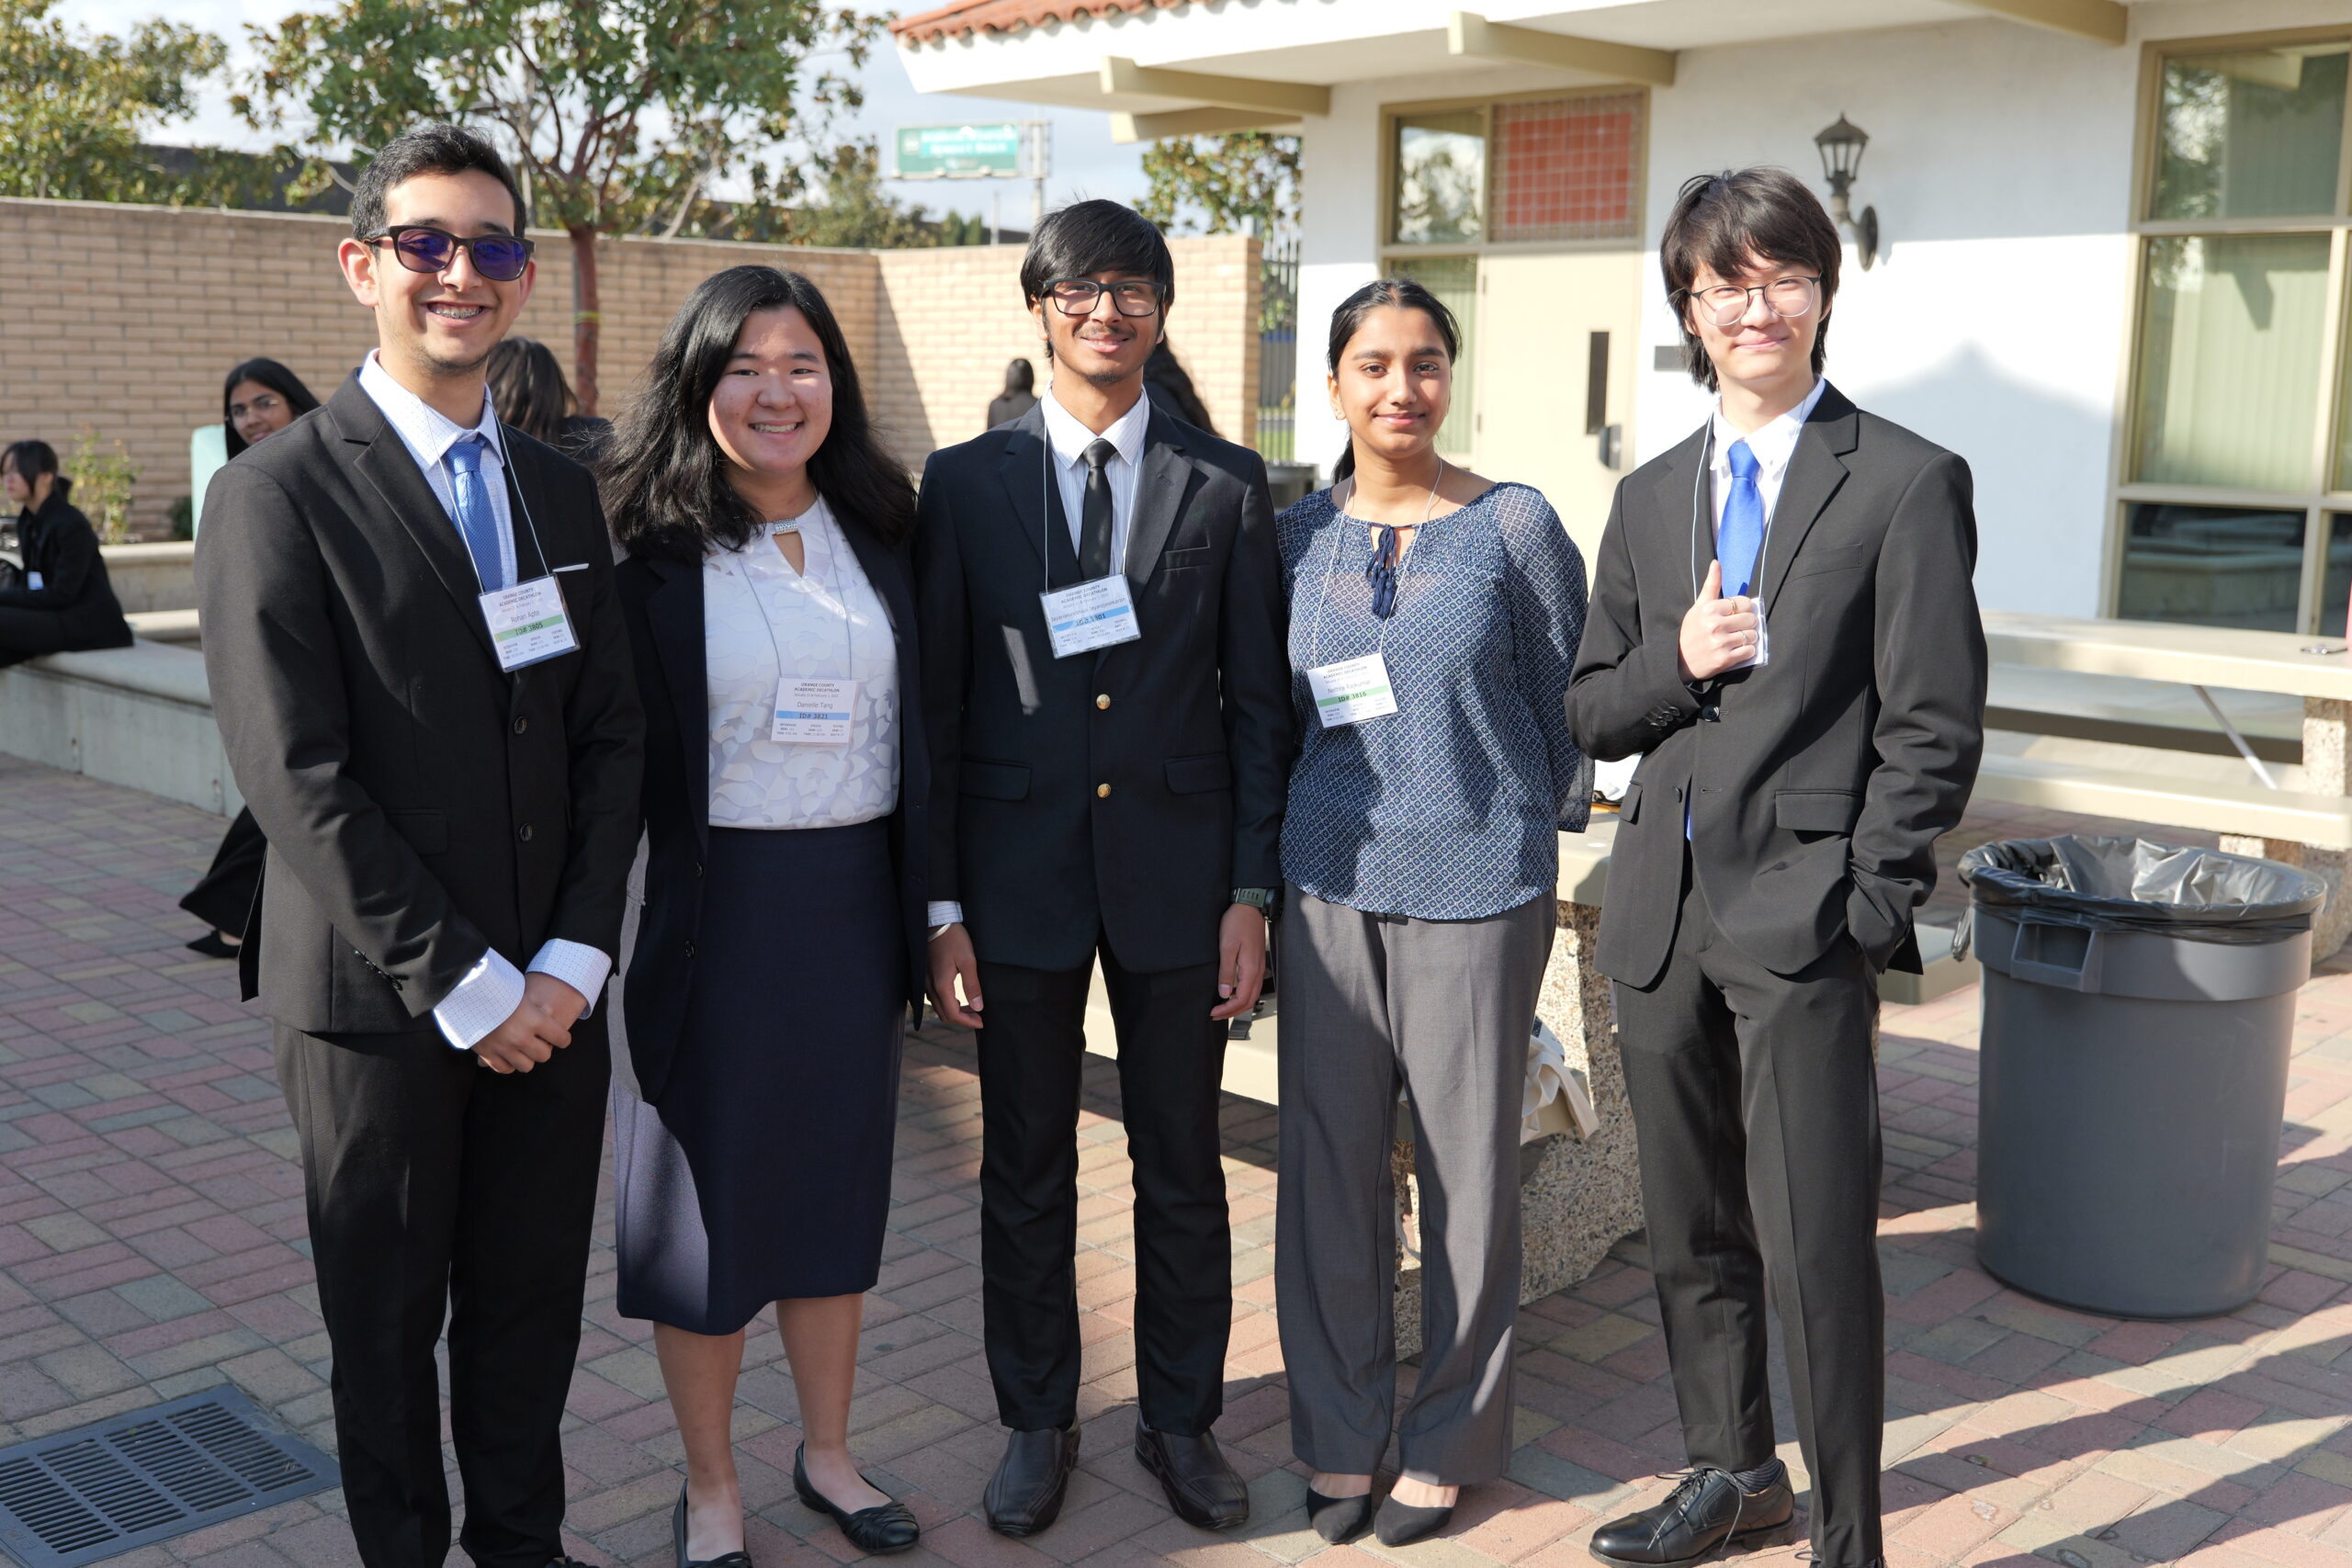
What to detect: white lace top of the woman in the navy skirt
<box><xmin>703</xmin><ymin>499</ymin><xmax>899</xmax><ymax>828</ymax></box>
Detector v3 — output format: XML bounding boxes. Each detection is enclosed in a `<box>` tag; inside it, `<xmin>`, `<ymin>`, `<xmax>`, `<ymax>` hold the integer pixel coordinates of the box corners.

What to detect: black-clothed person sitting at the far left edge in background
<box><xmin>0</xmin><ymin>442</ymin><xmax>131</xmax><ymax>668</ymax></box>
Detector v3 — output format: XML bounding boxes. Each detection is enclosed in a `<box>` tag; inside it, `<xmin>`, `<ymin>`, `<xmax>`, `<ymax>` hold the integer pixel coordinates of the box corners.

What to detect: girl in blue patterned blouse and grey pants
<box><xmin>1275</xmin><ymin>277</ymin><xmax>1592</xmax><ymax>1547</ymax></box>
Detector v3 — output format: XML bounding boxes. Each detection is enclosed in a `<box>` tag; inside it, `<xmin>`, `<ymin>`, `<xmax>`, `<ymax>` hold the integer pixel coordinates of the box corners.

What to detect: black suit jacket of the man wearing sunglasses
<box><xmin>195</xmin><ymin>376</ymin><xmax>644</xmax><ymax>1034</ymax></box>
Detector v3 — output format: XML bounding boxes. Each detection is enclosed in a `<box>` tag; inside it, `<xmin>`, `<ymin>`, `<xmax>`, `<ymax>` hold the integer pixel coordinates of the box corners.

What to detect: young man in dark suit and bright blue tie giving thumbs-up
<box><xmin>1569</xmin><ymin>169</ymin><xmax>1985</xmax><ymax>1568</ymax></box>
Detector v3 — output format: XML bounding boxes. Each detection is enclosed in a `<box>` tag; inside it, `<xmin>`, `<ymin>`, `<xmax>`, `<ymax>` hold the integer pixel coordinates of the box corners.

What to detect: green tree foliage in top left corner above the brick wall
<box><xmin>0</xmin><ymin>0</ymin><xmax>268</xmax><ymax>205</ymax></box>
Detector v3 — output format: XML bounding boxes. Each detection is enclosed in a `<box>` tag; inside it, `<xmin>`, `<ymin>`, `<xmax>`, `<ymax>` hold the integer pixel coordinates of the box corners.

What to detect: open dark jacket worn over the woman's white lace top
<box><xmin>614</xmin><ymin>522</ymin><xmax>932</xmax><ymax>1102</ymax></box>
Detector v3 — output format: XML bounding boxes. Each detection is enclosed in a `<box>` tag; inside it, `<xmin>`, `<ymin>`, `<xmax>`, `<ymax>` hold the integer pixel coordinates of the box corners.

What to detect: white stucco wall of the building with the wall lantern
<box><xmin>1298</xmin><ymin>0</ymin><xmax>2345</xmax><ymax>616</ymax></box>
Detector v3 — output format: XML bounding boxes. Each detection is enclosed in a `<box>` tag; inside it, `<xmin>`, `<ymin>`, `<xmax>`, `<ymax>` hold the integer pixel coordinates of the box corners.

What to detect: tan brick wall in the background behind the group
<box><xmin>0</xmin><ymin>197</ymin><xmax>1259</xmax><ymax>534</ymax></box>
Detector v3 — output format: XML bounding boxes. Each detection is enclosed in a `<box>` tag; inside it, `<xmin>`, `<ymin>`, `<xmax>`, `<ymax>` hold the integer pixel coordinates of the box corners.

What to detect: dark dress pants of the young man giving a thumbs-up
<box><xmin>1616</xmin><ymin>872</ymin><xmax>1886</xmax><ymax>1568</ymax></box>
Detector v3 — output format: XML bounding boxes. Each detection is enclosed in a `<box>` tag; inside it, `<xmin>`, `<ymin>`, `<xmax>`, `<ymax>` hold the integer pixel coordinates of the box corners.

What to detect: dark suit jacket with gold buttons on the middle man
<box><xmin>915</xmin><ymin>407</ymin><xmax>1296</xmax><ymax>974</ymax></box>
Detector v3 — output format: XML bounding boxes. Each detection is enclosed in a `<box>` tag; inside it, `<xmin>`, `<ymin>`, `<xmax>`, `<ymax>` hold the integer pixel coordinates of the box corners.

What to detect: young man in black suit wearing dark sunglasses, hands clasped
<box><xmin>195</xmin><ymin>125</ymin><xmax>642</xmax><ymax>1568</ymax></box>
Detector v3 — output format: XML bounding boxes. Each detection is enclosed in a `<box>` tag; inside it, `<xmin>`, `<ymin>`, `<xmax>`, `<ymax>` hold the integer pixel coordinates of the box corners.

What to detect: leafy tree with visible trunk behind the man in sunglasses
<box><xmin>238</xmin><ymin>0</ymin><xmax>882</xmax><ymax>413</ymax></box>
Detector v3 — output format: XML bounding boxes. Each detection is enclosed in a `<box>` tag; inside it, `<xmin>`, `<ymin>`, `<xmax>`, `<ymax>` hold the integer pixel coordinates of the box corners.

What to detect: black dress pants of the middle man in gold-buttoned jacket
<box><xmin>978</xmin><ymin>945</ymin><xmax>1232</xmax><ymax>1437</ymax></box>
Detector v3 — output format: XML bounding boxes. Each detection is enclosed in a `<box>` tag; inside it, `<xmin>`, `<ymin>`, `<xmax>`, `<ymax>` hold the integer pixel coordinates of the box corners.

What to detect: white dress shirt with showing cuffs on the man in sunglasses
<box><xmin>360</xmin><ymin>350</ymin><xmax>612</xmax><ymax>1051</ymax></box>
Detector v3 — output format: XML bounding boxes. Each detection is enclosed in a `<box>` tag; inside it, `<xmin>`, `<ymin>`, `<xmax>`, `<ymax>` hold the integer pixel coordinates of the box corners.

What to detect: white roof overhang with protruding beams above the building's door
<box><xmin>891</xmin><ymin>0</ymin><xmax>2129</xmax><ymax>139</ymax></box>
